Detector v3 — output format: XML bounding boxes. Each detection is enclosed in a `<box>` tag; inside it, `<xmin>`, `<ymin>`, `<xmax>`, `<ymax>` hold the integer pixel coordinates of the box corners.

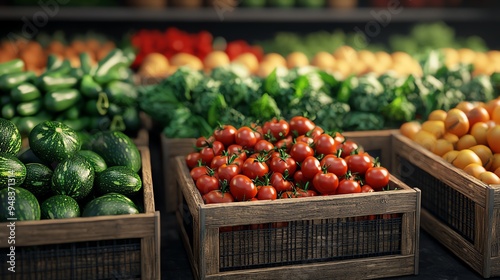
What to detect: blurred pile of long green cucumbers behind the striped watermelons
<box><xmin>0</xmin><ymin>49</ymin><xmax>141</xmax><ymax>137</ymax></box>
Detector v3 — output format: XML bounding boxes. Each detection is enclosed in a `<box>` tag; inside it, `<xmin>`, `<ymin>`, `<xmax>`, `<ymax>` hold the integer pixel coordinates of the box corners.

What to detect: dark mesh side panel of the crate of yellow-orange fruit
<box><xmin>398</xmin><ymin>157</ymin><xmax>476</xmax><ymax>242</ymax></box>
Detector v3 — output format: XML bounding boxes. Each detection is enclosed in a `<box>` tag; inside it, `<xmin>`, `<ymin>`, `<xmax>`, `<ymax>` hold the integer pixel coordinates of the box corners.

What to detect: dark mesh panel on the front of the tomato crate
<box><xmin>219</xmin><ymin>217</ymin><xmax>402</xmax><ymax>271</ymax></box>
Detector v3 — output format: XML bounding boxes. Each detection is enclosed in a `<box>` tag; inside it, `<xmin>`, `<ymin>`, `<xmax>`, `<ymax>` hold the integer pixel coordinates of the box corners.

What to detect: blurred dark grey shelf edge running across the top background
<box><xmin>0</xmin><ymin>6</ymin><xmax>500</xmax><ymax>23</ymax></box>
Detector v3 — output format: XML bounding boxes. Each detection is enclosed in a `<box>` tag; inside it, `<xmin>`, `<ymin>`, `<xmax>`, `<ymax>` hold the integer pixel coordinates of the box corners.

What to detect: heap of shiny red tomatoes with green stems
<box><xmin>186</xmin><ymin>116</ymin><xmax>390</xmax><ymax>204</ymax></box>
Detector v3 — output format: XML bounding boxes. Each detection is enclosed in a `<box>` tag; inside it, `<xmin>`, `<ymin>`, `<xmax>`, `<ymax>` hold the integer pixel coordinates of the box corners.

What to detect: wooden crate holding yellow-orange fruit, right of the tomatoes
<box><xmin>392</xmin><ymin>134</ymin><xmax>500</xmax><ymax>278</ymax></box>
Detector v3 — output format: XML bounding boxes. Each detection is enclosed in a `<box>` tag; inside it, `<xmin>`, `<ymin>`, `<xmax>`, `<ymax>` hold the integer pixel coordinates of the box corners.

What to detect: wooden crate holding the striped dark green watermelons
<box><xmin>0</xmin><ymin>147</ymin><xmax>161</xmax><ymax>280</ymax></box>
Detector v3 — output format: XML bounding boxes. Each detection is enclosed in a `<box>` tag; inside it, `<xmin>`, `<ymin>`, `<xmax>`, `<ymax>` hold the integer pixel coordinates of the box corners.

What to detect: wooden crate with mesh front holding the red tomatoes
<box><xmin>175</xmin><ymin>156</ymin><xmax>420</xmax><ymax>279</ymax></box>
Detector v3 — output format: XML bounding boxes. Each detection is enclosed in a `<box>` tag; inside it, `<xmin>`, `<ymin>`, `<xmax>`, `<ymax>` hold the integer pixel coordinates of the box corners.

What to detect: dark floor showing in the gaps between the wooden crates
<box><xmin>150</xmin><ymin>134</ymin><xmax>492</xmax><ymax>280</ymax></box>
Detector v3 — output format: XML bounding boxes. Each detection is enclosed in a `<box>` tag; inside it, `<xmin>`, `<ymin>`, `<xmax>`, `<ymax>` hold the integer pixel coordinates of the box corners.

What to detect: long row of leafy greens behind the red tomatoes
<box><xmin>139</xmin><ymin>52</ymin><xmax>500</xmax><ymax>138</ymax></box>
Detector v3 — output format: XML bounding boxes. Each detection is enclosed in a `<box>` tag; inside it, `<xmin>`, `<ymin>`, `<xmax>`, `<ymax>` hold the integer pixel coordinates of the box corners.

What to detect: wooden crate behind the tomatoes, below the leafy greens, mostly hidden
<box><xmin>161</xmin><ymin>130</ymin><xmax>394</xmax><ymax>213</ymax></box>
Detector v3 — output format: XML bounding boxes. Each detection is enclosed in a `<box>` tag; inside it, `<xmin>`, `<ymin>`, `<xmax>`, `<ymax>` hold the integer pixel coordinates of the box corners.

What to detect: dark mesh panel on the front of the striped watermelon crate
<box><xmin>0</xmin><ymin>239</ymin><xmax>141</xmax><ymax>280</ymax></box>
